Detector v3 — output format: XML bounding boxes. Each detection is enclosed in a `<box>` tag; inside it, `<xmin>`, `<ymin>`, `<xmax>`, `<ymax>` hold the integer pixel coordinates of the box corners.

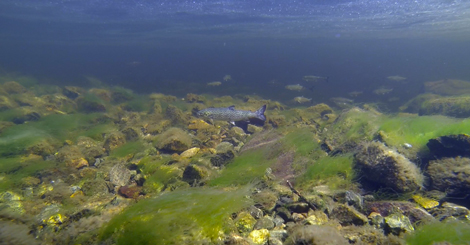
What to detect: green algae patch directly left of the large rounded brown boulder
<box><xmin>297</xmin><ymin>156</ymin><xmax>355</xmax><ymax>190</ymax></box>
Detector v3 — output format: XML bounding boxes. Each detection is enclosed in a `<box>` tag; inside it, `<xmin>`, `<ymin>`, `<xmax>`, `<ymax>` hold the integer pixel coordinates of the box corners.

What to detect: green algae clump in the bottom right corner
<box><xmin>406</xmin><ymin>221</ymin><xmax>470</xmax><ymax>245</ymax></box>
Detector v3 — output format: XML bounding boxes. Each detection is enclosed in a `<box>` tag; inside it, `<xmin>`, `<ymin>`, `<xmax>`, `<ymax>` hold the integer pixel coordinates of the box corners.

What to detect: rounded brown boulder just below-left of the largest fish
<box><xmin>155</xmin><ymin>128</ymin><xmax>192</xmax><ymax>152</ymax></box>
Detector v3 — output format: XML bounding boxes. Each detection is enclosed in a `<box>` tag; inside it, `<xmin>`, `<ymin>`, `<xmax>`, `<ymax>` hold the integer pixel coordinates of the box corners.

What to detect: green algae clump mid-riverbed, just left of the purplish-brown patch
<box><xmin>208</xmin><ymin>150</ymin><xmax>274</xmax><ymax>186</ymax></box>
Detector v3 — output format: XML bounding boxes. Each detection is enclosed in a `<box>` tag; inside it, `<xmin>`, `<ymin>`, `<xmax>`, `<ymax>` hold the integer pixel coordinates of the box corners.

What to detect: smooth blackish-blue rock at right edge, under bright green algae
<box><xmin>426</xmin><ymin>134</ymin><xmax>470</xmax><ymax>158</ymax></box>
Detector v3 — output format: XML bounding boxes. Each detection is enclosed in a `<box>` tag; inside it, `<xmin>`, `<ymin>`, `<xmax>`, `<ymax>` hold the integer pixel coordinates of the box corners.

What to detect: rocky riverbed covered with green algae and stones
<box><xmin>0</xmin><ymin>75</ymin><xmax>470</xmax><ymax>244</ymax></box>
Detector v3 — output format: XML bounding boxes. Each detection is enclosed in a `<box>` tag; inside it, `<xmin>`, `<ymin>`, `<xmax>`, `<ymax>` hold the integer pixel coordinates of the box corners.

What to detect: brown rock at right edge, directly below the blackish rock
<box><xmin>427</xmin><ymin>157</ymin><xmax>470</xmax><ymax>196</ymax></box>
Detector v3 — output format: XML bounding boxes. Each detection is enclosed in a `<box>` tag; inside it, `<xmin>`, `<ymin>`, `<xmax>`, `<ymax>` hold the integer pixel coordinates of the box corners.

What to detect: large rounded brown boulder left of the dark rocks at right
<box><xmin>355</xmin><ymin>142</ymin><xmax>424</xmax><ymax>192</ymax></box>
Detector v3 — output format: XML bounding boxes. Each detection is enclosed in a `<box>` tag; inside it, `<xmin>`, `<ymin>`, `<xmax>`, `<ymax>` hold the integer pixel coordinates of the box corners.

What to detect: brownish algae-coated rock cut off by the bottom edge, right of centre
<box><xmin>284</xmin><ymin>225</ymin><xmax>349</xmax><ymax>245</ymax></box>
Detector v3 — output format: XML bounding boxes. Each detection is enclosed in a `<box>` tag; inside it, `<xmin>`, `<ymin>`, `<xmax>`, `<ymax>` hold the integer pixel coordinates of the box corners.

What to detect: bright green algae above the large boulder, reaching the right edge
<box><xmin>379</xmin><ymin>116</ymin><xmax>470</xmax><ymax>150</ymax></box>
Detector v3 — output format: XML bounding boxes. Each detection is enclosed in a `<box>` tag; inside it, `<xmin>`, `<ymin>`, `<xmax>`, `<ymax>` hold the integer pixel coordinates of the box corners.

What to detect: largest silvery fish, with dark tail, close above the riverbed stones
<box><xmin>196</xmin><ymin>105</ymin><xmax>266</xmax><ymax>124</ymax></box>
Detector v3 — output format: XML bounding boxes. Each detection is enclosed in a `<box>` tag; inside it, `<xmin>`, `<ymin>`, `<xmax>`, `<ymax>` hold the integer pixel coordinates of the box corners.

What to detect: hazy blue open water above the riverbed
<box><xmin>0</xmin><ymin>0</ymin><xmax>470</xmax><ymax>104</ymax></box>
